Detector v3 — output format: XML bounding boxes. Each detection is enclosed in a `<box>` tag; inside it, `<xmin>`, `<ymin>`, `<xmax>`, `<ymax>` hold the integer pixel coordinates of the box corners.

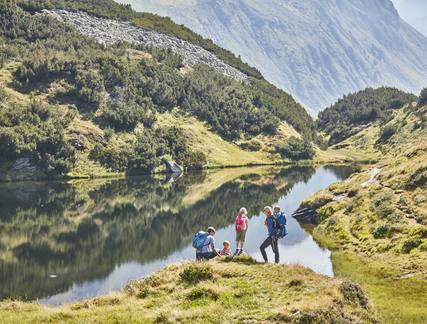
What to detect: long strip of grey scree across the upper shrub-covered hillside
<box><xmin>43</xmin><ymin>10</ymin><xmax>247</xmax><ymax>81</ymax></box>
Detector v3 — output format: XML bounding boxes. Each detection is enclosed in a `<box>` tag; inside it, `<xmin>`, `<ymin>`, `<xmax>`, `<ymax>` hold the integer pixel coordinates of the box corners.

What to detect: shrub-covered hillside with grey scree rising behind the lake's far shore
<box><xmin>0</xmin><ymin>0</ymin><xmax>315</xmax><ymax>180</ymax></box>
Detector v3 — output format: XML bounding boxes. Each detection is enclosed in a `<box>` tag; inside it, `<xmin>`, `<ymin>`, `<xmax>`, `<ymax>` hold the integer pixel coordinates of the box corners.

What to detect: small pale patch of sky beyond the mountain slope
<box><xmin>392</xmin><ymin>0</ymin><xmax>427</xmax><ymax>36</ymax></box>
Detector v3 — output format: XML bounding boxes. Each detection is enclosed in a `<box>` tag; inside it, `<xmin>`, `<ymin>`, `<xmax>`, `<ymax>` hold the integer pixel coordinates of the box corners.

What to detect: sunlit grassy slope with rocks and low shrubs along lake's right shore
<box><xmin>303</xmin><ymin>99</ymin><xmax>427</xmax><ymax>323</ymax></box>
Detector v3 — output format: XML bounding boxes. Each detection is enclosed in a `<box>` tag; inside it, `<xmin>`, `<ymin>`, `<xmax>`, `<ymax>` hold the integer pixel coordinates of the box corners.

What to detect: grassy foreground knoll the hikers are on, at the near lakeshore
<box><xmin>0</xmin><ymin>258</ymin><xmax>374</xmax><ymax>323</ymax></box>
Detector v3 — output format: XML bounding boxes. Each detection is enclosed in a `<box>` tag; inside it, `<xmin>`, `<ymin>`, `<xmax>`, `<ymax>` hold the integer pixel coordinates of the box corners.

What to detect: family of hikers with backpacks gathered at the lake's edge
<box><xmin>193</xmin><ymin>206</ymin><xmax>288</xmax><ymax>263</ymax></box>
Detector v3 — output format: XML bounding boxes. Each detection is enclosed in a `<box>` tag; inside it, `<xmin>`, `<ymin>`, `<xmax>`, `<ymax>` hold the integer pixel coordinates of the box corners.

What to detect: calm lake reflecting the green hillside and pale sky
<box><xmin>0</xmin><ymin>166</ymin><xmax>352</xmax><ymax>305</ymax></box>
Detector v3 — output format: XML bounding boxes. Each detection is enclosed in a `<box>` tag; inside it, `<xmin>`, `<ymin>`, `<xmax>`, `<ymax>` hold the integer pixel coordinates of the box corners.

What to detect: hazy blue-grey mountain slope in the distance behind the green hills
<box><xmin>120</xmin><ymin>0</ymin><xmax>427</xmax><ymax>112</ymax></box>
